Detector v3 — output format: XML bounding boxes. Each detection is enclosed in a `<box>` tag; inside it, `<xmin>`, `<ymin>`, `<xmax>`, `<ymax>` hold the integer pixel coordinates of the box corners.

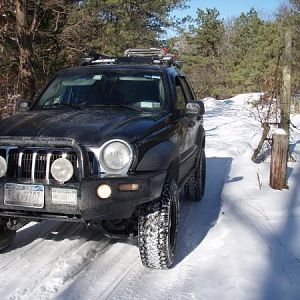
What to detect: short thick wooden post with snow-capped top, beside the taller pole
<box><xmin>270</xmin><ymin>129</ymin><xmax>289</xmax><ymax>190</ymax></box>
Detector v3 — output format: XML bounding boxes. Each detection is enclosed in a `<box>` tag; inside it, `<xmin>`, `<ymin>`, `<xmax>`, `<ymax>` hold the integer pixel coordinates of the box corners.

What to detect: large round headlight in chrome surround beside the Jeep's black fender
<box><xmin>100</xmin><ymin>140</ymin><xmax>133</xmax><ymax>173</ymax></box>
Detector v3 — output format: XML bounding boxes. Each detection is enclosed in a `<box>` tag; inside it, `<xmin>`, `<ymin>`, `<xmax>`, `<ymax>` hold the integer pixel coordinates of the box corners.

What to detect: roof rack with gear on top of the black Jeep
<box><xmin>81</xmin><ymin>48</ymin><xmax>181</xmax><ymax>68</ymax></box>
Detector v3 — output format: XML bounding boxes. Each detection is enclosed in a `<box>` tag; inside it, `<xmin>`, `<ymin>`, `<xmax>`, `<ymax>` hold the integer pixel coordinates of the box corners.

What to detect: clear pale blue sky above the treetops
<box><xmin>168</xmin><ymin>0</ymin><xmax>285</xmax><ymax>36</ymax></box>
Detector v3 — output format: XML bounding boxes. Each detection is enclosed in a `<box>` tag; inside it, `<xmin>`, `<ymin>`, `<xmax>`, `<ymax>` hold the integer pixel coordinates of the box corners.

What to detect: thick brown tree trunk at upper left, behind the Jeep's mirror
<box><xmin>15</xmin><ymin>0</ymin><xmax>36</xmax><ymax>100</ymax></box>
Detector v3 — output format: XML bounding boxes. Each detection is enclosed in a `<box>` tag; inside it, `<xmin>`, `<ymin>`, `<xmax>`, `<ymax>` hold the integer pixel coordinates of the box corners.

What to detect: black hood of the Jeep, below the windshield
<box><xmin>0</xmin><ymin>108</ymin><xmax>165</xmax><ymax>146</ymax></box>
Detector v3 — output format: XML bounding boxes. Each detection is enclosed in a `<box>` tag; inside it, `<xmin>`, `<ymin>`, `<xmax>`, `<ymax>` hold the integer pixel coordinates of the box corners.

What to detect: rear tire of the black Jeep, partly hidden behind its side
<box><xmin>184</xmin><ymin>149</ymin><xmax>206</xmax><ymax>201</ymax></box>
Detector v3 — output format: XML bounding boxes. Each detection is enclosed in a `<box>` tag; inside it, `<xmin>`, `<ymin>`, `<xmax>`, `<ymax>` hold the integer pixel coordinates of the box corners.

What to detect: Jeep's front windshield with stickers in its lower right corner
<box><xmin>34</xmin><ymin>71</ymin><xmax>165</xmax><ymax>111</ymax></box>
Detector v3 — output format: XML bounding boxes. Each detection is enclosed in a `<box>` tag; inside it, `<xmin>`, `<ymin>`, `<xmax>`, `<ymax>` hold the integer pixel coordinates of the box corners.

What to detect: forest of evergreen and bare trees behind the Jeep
<box><xmin>0</xmin><ymin>0</ymin><xmax>300</xmax><ymax>117</ymax></box>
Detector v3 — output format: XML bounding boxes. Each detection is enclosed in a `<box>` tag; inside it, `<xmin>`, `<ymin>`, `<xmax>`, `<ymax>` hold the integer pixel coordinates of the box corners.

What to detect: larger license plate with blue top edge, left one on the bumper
<box><xmin>4</xmin><ymin>183</ymin><xmax>45</xmax><ymax>208</ymax></box>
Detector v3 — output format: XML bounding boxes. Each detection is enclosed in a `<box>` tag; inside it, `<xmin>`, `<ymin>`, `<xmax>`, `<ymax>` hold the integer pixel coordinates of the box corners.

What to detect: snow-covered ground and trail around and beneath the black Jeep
<box><xmin>0</xmin><ymin>94</ymin><xmax>300</xmax><ymax>300</ymax></box>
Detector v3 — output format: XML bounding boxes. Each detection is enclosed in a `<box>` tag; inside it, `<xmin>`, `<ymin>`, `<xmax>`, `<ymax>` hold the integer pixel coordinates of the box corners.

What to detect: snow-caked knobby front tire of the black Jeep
<box><xmin>138</xmin><ymin>179</ymin><xmax>179</xmax><ymax>269</ymax></box>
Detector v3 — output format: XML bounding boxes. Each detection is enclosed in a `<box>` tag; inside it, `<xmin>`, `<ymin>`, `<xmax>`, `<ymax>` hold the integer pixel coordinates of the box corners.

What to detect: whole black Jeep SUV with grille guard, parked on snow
<box><xmin>0</xmin><ymin>49</ymin><xmax>205</xmax><ymax>269</ymax></box>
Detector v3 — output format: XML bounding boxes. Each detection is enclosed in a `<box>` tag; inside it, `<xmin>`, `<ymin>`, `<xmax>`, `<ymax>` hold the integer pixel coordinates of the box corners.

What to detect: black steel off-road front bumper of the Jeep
<box><xmin>0</xmin><ymin>171</ymin><xmax>166</xmax><ymax>222</ymax></box>
